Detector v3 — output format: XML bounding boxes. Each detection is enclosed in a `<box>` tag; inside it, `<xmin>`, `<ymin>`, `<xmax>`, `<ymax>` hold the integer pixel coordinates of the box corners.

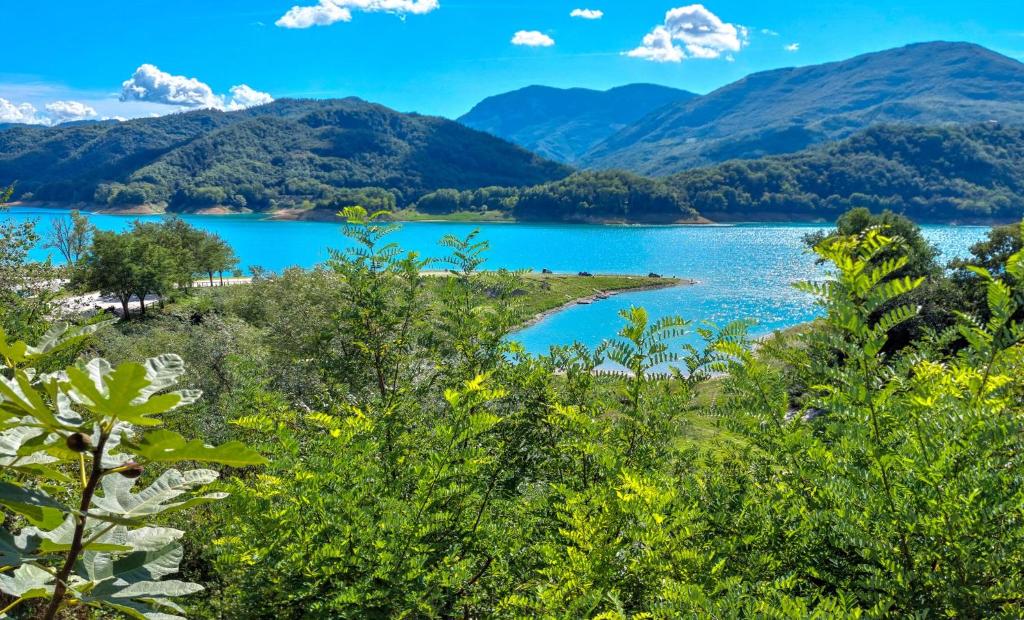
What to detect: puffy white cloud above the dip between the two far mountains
<box><xmin>625</xmin><ymin>4</ymin><xmax>750</xmax><ymax>63</ymax></box>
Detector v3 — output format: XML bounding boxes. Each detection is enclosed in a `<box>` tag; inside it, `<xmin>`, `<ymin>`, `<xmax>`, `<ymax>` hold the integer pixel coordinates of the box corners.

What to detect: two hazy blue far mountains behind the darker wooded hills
<box><xmin>462</xmin><ymin>42</ymin><xmax>1024</xmax><ymax>175</ymax></box>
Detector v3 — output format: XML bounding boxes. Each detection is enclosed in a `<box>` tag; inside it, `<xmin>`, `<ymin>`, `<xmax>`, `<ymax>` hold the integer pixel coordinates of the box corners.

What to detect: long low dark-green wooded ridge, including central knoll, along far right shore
<box><xmin>418</xmin><ymin>123</ymin><xmax>1024</xmax><ymax>221</ymax></box>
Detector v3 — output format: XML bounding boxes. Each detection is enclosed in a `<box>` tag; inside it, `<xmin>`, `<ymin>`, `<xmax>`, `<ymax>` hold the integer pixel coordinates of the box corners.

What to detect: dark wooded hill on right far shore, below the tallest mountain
<box><xmin>665</xmin><ymin>123</ymin><xmax>1024</xmax><ymax>221</ymax></box>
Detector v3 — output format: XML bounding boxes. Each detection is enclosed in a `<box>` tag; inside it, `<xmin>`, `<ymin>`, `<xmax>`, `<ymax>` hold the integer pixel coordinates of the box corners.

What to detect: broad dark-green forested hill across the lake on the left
<box><xmin>0</xmin><ymin>98</ymin><xmax>570</xmax><ymax>210</ymax></box>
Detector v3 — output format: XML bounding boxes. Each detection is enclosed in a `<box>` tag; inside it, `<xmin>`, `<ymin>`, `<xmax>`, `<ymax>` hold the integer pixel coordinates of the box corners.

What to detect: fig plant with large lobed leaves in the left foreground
<box><xmin>0</xmin><ymin>325</ymin><xmax>265</xmax><ymax>619</ymax></box>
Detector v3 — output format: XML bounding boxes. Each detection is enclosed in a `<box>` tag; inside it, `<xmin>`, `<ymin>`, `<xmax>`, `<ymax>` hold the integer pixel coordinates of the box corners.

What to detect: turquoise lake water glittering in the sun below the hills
<box><xmin>2</xmin><ymin>207</ymin><xmax>987</xmax><ymax>353</ymax></box>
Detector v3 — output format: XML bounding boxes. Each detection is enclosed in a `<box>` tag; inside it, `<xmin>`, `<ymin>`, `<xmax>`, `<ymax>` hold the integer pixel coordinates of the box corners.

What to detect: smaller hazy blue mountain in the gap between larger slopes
<box><xmin>459</xmin><ymin>84</ymin><xmax>696</xmax><ymax>163</ymax></box>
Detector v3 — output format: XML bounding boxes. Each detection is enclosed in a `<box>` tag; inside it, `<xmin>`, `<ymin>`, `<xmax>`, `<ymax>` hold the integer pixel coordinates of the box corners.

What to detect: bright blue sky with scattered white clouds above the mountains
<box><xmin>0</xmin><ymin>0</ymin><xmax>1024</xmax><ymax>124</ymax></box>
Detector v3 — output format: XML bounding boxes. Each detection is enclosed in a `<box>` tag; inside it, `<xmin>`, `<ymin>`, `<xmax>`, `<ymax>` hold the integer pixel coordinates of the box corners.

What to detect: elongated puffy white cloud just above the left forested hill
<box><xmin>121</xmin><ymin>65</ymin><xmax>273</xmax><ymax>110</ymax></box>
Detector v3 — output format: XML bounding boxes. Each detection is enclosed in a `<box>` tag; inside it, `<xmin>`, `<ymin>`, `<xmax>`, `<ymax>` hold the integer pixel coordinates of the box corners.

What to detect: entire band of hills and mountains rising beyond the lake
<box><xmin>6</xmin><ymin>43</ymin><xmax>1024</xmax><ymax>221</ymax></box>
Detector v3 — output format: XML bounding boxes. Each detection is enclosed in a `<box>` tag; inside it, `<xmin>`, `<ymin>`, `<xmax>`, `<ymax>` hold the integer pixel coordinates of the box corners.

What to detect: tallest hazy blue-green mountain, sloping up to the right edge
<box><xmin>581</xmin><ymin>42</ymin><xmax>1024</xmax><ymax>175</ymax></box>
